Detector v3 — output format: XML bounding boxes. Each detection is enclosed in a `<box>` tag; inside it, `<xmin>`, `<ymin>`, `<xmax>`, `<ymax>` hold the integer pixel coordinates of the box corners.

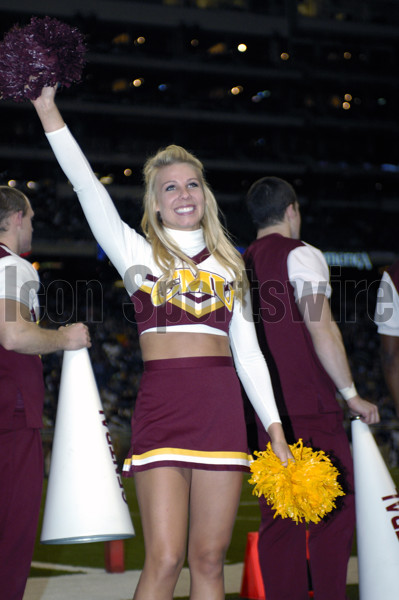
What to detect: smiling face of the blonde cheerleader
<box><xmin>156</xmin><ymin>163</ymin><xmax>205</xmax><ymax>231</ymax></box>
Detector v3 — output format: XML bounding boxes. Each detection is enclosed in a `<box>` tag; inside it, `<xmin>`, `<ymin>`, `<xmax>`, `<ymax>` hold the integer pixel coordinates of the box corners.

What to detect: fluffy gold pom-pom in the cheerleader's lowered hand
<box><xmin>249</xmin><ymin>439</ymin><xmax>345</xmax><ymax>523</ymax></box>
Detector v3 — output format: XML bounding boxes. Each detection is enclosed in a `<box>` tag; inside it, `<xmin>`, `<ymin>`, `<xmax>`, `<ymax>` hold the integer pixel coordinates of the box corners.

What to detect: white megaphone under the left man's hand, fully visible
<box><xmin>40</xmin><ymin>348</ymin><xmax>134</xmax><ymax>544</ymax></box>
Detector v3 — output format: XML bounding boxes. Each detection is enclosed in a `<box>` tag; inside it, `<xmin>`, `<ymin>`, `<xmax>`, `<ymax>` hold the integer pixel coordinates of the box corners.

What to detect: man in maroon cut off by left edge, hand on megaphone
<box><xmin>0</xmin><ymin>186</ymin><xmax>91</xmax><ymax>600</ymax></box>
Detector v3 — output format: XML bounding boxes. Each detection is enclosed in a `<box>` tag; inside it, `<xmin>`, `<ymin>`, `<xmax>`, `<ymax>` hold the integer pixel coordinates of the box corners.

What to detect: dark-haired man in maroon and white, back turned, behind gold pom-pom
<box><xmin>244</xmin><ymin>177</ymin><xmax>379</xmax><ymax>600</ymax></box>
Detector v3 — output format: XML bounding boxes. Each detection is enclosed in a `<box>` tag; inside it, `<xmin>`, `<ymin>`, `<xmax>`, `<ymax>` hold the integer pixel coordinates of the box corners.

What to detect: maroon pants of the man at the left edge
<box><xmin>0</xmin><ymin>417</ymin><xmax>43</xmax><ymax>600</ymax></box>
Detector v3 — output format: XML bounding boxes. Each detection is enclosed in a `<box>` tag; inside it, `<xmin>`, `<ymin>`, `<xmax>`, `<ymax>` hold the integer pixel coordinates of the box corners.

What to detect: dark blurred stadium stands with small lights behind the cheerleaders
<box><xmin>0</xmin><ymin>0</ymin><xmax>399</xmax><ymax>466</ymax></box>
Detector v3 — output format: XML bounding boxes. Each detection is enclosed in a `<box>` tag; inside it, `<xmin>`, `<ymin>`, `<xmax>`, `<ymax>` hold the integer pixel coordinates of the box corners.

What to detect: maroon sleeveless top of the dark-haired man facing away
<box><xmin>244</xmin><ymin>234</ymin><xmax>341</xmax><ymax>417</ymax></box>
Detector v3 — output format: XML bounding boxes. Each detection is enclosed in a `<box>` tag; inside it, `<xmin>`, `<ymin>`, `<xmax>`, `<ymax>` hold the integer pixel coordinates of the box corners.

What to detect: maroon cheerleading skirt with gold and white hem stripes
<box><xmin>123</xmin><ymin>356</ymin><xmax>251</xmax><ymax>476</ymax></box>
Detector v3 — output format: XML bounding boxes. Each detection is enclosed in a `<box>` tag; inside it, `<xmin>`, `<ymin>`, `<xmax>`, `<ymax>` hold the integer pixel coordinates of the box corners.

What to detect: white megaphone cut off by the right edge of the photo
<box><xmin>352</xmin><ymin>419</ymin><xmax>399</xmax><ymax>600</ymax></box>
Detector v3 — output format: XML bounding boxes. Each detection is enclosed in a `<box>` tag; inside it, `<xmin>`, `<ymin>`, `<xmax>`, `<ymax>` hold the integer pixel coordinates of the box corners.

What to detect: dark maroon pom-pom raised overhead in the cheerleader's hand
<box><xmin>0</xmin><ymin>17</ymin><xmax>86</xmax><ymax>102</ymax></box>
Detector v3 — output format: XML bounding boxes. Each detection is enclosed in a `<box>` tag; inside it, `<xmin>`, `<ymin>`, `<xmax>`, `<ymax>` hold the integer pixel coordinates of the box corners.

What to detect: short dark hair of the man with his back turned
<box><xmin>246</xmin><ymin>177</ymin><xmax>298</xmax><ymax>229</ymax></box>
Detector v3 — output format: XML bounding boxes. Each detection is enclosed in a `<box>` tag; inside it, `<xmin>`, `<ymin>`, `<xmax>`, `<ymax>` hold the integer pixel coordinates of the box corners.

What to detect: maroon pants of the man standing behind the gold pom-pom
<box><xmin>259</xmin><ymin>414</ymin><xmax>355</xmax><ymax>600</ymax></box>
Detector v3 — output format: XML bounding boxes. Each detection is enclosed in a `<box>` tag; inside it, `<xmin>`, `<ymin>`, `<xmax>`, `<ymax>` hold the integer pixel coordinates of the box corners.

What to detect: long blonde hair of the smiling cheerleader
<box><xmin>141</xmin><ymin>145</ymin><xmax>248</xmax><ymax>300</ymax></box>
